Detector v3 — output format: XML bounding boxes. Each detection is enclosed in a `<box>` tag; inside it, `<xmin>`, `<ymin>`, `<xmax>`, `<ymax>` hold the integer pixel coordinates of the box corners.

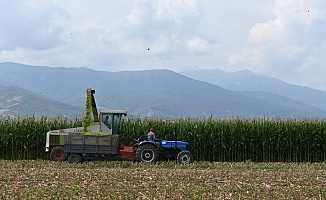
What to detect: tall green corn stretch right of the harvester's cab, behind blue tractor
<box><xmin>122</xmin><ymin>118</ymin><xmax>326</xmax><ymax>162</ymax></box>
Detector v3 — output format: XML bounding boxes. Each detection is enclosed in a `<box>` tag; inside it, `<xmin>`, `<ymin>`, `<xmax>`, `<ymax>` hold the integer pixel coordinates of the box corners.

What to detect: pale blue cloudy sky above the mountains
<box><xmin>0</xmin><ymin>0</ymin><xmax>326</xmax><ymax>91</ymax></box>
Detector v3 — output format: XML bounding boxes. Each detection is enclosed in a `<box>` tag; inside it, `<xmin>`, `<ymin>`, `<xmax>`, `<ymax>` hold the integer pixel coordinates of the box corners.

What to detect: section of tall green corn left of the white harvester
<box><xmin>0</xmin><ymin>116</ymin><xmax>77</xmax><ymax>160</ymax></box>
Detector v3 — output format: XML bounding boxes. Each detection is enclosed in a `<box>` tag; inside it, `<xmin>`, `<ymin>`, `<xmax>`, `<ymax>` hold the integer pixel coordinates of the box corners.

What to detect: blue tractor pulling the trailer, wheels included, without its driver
<box><xmin>136</xmin><ymin>130</ymin><xmax>193</xmax><ymax>164</ymax></box>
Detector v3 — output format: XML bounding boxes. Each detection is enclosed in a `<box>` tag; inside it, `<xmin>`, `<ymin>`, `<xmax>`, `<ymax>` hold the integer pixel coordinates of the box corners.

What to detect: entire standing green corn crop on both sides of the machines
<box><xmin>0</xmin><ymin>117</ymin><xmax>326</xmax><ymax>162</ymax></box>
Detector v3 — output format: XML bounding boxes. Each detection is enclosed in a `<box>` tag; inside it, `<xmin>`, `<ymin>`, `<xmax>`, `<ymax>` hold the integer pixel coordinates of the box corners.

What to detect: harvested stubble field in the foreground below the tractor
<box><xmin>0</xmin><ymin>160</ymin><xmax>326</xmax><ymax>199</ymax></box>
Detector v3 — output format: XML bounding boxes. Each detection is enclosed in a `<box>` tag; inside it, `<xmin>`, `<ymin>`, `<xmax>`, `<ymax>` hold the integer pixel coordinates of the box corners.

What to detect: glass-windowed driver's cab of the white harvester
<box><xmin>99</xmin><ymin>110</ymin><xmax>127</xmax><ymax>134</ymax></box>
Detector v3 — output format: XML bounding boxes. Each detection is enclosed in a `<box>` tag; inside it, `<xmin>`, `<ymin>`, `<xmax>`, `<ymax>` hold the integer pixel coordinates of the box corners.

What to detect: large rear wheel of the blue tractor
<box><xmin>136</xmin><ymin>144</ymin><xmax>158</xmax><ymax>163</ymax></box>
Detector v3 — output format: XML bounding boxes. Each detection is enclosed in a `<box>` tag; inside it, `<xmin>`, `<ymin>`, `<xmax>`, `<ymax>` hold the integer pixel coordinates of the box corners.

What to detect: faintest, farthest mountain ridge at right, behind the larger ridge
<box><xmin>181</xmin><ymin>69</ymin><xmax>326</xmax><ymax>111</ymax></box>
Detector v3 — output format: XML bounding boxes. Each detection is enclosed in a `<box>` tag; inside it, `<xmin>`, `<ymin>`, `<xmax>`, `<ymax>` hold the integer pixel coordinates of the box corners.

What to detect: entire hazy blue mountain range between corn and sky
<box><xmin>0</xmin><ymin>62</ymin><xmax>326</xmax><ymax>118</ymax></box>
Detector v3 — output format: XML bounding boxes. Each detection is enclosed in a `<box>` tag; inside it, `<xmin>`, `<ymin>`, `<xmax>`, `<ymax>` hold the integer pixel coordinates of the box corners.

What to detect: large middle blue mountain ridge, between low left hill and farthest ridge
<box><xmin>0</xmin><ymin>63</ymin><xmax>326</xmax><ymax>118</ymax></box>
